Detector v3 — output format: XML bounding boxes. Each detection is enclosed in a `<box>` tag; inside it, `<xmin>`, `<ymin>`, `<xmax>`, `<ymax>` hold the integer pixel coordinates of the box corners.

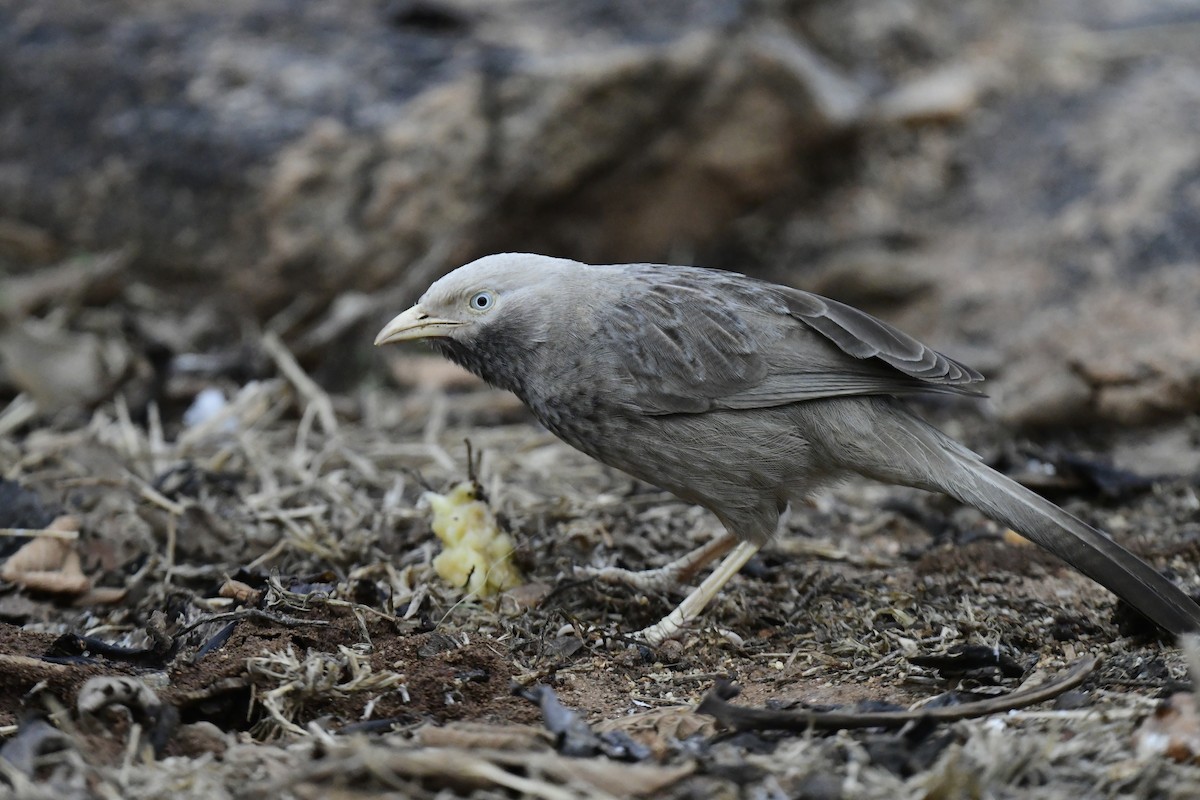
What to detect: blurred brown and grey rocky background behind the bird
<box><xmin>7</xmin><ymin>0</ymin><xmax>1200</xmax><ymax>426</ymax></box>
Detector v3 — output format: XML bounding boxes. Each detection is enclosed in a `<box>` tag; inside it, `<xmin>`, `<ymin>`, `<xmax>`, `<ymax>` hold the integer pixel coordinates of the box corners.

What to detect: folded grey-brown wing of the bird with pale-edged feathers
<box><xmin>598</xmin><ymin>265</ymin><xmax>983</xmax><ymax>414</ymax></box>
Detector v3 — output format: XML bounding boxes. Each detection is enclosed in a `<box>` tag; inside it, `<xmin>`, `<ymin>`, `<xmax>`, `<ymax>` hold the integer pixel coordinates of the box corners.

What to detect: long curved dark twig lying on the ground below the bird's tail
<box><xmin>696</xmin><ymin>656</ymin><xmax>1097</xmax><ymax>730</ymax></box>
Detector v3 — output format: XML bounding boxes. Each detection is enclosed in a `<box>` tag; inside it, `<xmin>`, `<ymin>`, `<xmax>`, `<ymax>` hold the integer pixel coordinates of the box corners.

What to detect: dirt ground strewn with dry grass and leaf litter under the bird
<box><xmin>0</xmin><ymin>367</ymin><xmax>1200</xmax><ymax>799</ymax></box>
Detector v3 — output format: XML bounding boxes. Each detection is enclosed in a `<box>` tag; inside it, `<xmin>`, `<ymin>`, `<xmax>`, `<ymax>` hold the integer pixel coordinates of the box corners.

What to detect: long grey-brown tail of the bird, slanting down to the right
<box><xmin>840</xmin><ymin>402</ymin><xmax>1200</xmax><ymax>636</ymax></box>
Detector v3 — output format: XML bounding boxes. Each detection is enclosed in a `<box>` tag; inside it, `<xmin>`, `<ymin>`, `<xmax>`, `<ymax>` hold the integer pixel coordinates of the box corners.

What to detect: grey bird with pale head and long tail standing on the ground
<box><xmin>376</xmin><ymin>253</ymin><xmax>1200</xmax><ymax>644</ymax></box>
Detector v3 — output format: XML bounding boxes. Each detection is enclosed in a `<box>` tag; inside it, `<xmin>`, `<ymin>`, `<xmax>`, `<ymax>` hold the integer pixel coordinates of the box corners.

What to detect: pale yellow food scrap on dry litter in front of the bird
<box><xmin>424</xmin><ymin>481</ymin><xmax>523</xmax><ymax>597</ymax></box>
